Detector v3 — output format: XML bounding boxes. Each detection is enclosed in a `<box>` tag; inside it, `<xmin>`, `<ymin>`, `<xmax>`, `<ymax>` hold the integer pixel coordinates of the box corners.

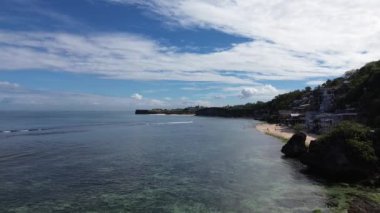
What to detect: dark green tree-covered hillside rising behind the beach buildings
<box><xmin>196</xmin><ymin>61</ymin><xmax>380</xmax><ymax>128</ymax></box>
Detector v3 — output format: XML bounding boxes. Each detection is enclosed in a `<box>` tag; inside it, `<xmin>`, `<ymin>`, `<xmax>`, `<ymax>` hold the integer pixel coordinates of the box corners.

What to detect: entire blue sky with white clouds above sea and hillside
<box><xmin>0</xmin><ymin>0</ymin><xmax>380</xmax><ymax>110</ymax></box>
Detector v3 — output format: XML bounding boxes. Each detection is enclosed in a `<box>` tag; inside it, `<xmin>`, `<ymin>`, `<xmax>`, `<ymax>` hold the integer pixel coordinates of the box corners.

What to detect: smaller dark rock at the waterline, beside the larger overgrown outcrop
<box><xmin>281</xmin><ymin>132</ymin><xmax>307</xmax><ymax>158</ymax></box>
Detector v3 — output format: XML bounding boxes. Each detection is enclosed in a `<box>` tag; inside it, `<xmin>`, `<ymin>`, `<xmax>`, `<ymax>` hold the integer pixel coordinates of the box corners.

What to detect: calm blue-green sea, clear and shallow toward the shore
<box><xmin>0</xmin><ymin>112</ymin><xmax>327</xmax><ymax>212</ymax></box>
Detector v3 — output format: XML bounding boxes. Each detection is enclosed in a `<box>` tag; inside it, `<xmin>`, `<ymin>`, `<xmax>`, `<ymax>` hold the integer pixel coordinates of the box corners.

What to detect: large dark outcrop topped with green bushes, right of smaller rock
<box><xmin>301</xmin><ymin>122</ymin><xmax>378</xmax><ymax>179</ymax></box>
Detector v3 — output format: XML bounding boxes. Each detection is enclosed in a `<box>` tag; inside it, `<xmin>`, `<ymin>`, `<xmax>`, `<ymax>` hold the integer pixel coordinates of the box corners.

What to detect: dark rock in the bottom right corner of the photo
<box><xmin>348</xmin><ymin>197</ymin><xmax>380</xmax><ymax>213</ymax></box>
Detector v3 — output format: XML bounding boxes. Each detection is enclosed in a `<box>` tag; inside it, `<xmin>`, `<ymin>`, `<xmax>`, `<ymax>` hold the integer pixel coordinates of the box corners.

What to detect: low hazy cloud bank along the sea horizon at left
<box><xmin>0</xmin><ymin>81</ymin><xmax>212</xmax><ymax>111</ymax></box>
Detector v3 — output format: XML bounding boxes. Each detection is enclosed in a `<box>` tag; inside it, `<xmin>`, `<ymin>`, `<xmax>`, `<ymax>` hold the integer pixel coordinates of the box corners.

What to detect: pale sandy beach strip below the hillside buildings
<box><xmin>256</xmin><ymin>123</ymin><xmax>317</xmax><ymax>146</ymax></box>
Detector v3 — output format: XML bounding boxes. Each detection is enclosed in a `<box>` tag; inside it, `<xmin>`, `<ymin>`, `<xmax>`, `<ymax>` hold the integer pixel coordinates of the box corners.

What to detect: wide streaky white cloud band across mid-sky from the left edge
<box><xmin>0</xmin><ymin>31</ymin><xmax>252</xmax><ymax>83</ymax></box>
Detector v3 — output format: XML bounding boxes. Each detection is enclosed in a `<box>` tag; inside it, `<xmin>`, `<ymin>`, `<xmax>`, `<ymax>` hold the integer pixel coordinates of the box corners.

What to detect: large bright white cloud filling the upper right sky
<box><xmin>106</xmin><ymin>0</ymin><xmax>380</xmax><ymax>77</ymax></box>
